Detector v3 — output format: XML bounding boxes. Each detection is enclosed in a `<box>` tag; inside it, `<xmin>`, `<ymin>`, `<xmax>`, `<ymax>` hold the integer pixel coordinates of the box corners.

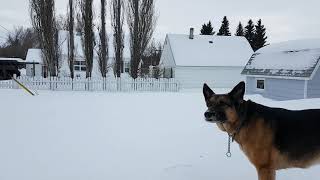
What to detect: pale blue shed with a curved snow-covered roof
<box><xmin>242</xmin><ymin>39</ymin><xmax>320</xmax><ymax>100</ymax></box>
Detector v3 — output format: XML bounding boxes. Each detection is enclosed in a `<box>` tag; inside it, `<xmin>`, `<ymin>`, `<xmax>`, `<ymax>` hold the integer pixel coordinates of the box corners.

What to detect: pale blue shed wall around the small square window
<box><xmin>246</xmin><ymin>77</ymin><xmax>304</xmax><ymax>100</ymax></box>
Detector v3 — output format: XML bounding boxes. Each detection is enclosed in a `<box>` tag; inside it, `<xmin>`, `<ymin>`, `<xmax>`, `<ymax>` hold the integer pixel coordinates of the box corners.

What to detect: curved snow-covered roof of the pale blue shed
<box><xmin>242</xmin><ymin>39</ymin><xmax>320</xmax><ymax>79</ymax></box>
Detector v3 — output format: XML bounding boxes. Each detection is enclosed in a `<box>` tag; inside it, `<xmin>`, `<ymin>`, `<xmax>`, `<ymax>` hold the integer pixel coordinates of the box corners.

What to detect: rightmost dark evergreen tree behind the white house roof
<box><xmin>253</xmin><ymin>19</ymin><xmax>268</xmax><ymax>51</ymax></box>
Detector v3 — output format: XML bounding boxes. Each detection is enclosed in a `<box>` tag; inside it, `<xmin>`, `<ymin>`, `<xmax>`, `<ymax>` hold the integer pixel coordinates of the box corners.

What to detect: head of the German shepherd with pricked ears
<box><xmin>203</xmin><ymin>82</ymin><xmax>245</xmax><ymax>123</ymax></box>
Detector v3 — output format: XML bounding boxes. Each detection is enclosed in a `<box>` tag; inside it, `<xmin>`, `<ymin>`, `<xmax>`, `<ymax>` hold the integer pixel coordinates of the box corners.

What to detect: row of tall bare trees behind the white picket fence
<box><xmin>25</xmin><ymin>0</ymin><xmax>157</xmax><ymax>78</ymax></box>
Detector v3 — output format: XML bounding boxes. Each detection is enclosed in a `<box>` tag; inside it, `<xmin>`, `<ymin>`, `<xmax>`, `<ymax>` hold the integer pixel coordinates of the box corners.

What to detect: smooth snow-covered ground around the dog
<box><xmin>0</xmin><ymin>89</ymin><xmax>320</xmax><ymax>180</ymax></box>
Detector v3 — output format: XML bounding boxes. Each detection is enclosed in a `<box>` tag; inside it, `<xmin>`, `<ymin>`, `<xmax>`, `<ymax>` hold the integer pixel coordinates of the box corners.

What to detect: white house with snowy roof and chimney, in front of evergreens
<box><xmin>160</xmin><ymin>29</ymin><xmax>253</xmax><ymax>88</ymax></box>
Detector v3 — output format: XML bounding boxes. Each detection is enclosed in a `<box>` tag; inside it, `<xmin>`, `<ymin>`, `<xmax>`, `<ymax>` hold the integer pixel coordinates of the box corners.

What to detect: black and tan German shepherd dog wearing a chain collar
<box><xmin>203</xmin><ymin>82</ymin><xmax>320</xmax><ymax>180</ymax></box>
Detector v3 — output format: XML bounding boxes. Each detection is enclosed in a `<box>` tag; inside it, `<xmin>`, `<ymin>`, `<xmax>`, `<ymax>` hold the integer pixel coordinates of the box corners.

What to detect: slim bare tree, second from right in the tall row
<box><xmin>111</xmin><ymin>0</ymin><xmax>124</xmax><ymax>77</ymax></box>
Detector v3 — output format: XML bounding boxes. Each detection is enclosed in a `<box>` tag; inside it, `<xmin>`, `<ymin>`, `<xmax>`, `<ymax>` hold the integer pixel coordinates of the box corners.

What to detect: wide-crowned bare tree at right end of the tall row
<box><xmin>127</xmin><ymin>0</ymin><xmax>157</xmax><ymax>78</ymax></box>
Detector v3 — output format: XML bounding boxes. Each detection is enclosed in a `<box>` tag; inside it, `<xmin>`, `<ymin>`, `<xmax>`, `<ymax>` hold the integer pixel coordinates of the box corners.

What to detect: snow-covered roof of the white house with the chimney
<box><xmin>166</xmin><ymin>34</ymin><xmax>253</xmax><ymax>66</ymax></box>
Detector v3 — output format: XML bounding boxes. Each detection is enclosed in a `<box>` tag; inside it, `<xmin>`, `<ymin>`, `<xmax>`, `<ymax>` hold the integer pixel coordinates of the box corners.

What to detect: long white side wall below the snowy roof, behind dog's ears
<box><xmin>175</xmin><ymin>66</ymin><xmax>245</xmax><ymax>89</ymax></box>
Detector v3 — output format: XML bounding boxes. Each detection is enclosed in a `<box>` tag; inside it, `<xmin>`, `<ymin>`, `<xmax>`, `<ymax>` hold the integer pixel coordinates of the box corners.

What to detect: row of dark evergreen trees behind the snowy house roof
<box><xmin>200</xmin><ymin>16</ymin><xmax>268</xmax><ymax>51</ymax></box>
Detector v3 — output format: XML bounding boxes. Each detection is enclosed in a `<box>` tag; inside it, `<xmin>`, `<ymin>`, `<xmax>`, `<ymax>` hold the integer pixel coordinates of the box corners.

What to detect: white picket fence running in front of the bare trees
<box><xmin>0</xmin><ymin>76</ymin><xmax>180</xmax><ymax>92</ymax></box>
